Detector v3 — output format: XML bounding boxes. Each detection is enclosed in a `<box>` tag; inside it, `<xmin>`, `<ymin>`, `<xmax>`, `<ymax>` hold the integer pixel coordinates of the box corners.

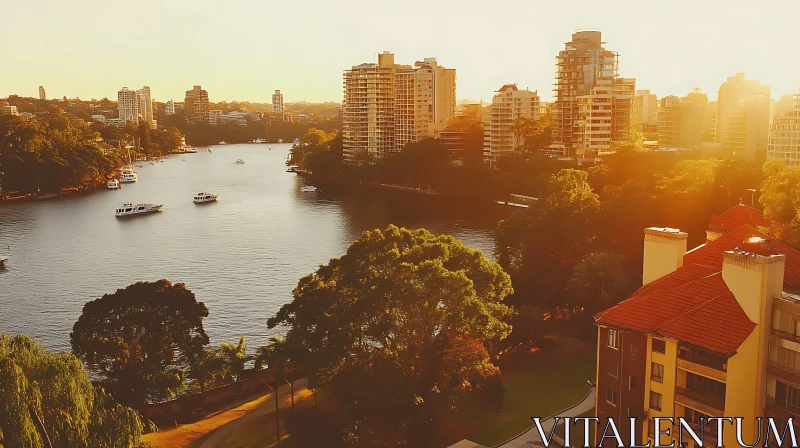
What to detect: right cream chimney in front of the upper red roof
<box><xmin>722</xmin><ymin>243</ymin><xmax>786</xmax><ymax>327</ymax></box>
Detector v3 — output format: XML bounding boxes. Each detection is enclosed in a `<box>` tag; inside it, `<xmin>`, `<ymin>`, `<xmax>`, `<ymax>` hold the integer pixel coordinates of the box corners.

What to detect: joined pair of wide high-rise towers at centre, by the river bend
<box><xmin>342</xmin><ymin>51</ymin><xmax>455</xmax><ymax>164</ymax></box>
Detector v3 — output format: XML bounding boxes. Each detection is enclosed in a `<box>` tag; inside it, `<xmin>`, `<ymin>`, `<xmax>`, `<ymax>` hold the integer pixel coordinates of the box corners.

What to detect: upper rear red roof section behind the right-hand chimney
<box><xmin>683</xmin><ymin>226</ymin><xmax>800</xmax><ymax>286</ymax></box>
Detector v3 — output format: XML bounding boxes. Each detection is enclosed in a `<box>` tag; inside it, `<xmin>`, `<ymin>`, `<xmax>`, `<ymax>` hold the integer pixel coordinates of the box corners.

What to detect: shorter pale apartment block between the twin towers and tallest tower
<box><xmin>483</xmin><ymin>84</ymin><xmax>539</xmax><ymax>165</ymax></box>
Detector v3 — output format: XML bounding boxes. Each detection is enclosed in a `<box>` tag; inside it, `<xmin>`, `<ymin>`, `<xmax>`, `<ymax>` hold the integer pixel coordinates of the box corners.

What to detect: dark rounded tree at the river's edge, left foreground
<box><xmin>70</xmin><ymin>280</ymin><xmax>208</xmax><ymax>406</ymax></box>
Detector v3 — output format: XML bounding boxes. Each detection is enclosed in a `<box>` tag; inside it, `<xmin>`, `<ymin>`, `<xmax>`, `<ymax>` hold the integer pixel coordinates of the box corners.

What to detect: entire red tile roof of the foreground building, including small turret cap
<box><xmin>595</xmin><ymin>205</ymin><xmax>800</xmax><ymax>355</ymax></box>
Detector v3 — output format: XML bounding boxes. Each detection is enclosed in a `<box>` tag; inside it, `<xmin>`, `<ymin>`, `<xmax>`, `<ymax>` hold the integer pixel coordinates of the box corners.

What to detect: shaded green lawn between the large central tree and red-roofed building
<box><xmin>441</xmin><ymin>347</ymin><xmax>596</xmax><ymax>446</ymax></box>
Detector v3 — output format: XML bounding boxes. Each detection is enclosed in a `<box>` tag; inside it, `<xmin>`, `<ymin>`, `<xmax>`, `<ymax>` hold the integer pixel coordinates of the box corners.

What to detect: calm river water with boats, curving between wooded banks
<box><xmin>0</xmin><ymin>144</ymin><xmax>505</xmax><ymax>353</ymax></box>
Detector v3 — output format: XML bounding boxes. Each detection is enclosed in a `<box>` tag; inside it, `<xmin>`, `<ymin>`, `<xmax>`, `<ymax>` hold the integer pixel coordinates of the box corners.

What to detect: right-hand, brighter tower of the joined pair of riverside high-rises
<box><xmin>394</xmin><ymin>58</ymin><xmax>456</xmax><ymax>151</ymax></box>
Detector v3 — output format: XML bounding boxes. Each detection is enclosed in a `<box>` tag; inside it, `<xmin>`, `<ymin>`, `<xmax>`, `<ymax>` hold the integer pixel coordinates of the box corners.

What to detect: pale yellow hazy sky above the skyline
<box><xmin>0</xmin><ymin>0</ymin><xmax>800</xmax><ymax>102</ymax></box>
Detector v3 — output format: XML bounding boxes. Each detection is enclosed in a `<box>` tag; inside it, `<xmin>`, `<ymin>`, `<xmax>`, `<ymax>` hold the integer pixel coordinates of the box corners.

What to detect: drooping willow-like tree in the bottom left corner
<box><xmin>0</xmin><ymin>334</ymin><xmax>149</xmax><ymax>448</ymax></box>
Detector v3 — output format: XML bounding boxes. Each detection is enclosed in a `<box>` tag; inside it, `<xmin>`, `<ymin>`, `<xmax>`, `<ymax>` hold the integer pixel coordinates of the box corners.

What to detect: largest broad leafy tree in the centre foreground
<box><xmin>268</xmin><ymin>226</ymin><xmax>511</xmax><ymax>446</ymax></box>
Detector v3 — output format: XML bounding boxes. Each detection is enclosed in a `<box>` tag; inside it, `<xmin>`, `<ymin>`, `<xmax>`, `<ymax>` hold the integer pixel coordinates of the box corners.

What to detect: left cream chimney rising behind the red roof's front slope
<box><xmin>642</xmin><ymin>227</ymin><xmax>689</xmax><ymax>285</ymax></box>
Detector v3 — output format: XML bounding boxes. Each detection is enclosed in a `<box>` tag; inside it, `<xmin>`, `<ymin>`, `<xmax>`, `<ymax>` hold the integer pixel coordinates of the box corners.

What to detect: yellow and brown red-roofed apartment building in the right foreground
<box><xmin>595</xmin><ymin>205</ymin><xmax>800</xmax><ymax>447</ymax></box>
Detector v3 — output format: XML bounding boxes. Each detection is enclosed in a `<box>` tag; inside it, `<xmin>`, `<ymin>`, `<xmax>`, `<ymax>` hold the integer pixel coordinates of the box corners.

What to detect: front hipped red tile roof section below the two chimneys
<box><xmin>595</xmin><ymin>272</ymin><xmax>755</xmax><ymax>355</ymax></box>
